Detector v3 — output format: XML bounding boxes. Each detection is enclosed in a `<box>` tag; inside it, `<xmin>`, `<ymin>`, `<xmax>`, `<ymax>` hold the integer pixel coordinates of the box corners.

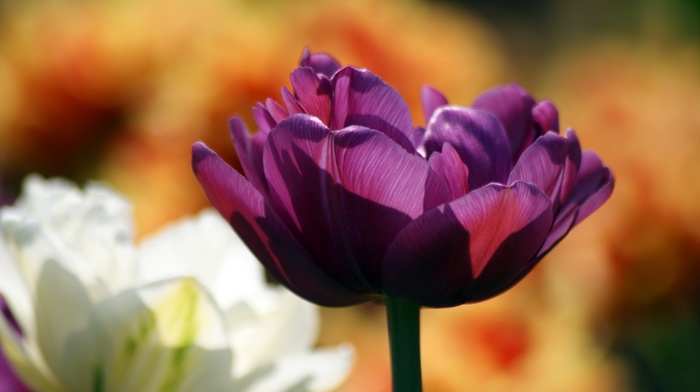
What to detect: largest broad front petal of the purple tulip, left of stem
<box><xmin>263</xmin><ymin>115</ymin><xmax>446</xmax><ymax>292</ymax></box>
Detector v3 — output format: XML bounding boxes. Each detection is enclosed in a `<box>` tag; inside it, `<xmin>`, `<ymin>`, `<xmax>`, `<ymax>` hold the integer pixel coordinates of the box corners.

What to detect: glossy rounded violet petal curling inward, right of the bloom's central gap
<box><xmin>424</xmin><ymin>106</ymin><xmax>511</xmax><ymax>189</ymax></box>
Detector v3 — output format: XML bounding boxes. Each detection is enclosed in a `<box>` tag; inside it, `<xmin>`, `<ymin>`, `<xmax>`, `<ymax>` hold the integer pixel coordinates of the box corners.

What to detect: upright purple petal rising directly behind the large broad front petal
<box><xmin>330</xmin><ymin>67</ymin><xmax>415</xmax><ymax>152</ymax></box>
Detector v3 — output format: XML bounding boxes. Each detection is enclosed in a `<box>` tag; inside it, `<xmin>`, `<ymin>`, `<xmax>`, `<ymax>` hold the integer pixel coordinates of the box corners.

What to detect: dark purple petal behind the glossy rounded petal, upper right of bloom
<box><xmin>472</xmin><ymin>83</ymin><xmax>535</xmax><ymax>161</ymax></box>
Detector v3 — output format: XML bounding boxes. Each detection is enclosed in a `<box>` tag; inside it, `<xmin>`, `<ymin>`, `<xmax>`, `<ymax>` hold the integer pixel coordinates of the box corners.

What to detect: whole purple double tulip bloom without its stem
<box><xmin>192</xmin><ymin>52</ymin><xmax>613</xmax><ymax>307</ymax></box>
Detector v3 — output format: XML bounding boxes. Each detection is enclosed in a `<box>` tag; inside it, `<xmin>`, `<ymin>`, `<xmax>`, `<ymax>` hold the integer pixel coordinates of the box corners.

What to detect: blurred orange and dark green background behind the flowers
<box><xmin>0</xmin><ymin>0</ymin><xmax>700</xmax><ymax>392</ymax></box>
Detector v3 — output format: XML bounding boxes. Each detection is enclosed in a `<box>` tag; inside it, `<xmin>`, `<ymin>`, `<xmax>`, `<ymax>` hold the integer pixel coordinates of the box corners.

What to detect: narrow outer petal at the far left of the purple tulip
<box><xmin>192</xmin><ymin>143</ymin><xmax>369</xmax><ymax>306</ymax></box>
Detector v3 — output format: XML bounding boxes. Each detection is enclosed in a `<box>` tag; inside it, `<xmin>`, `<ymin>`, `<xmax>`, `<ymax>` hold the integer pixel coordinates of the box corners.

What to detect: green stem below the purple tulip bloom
<box><xmin>385</xmin><ymin>297</ymin><xmax>423</xmax><ymax>392</ymax></box>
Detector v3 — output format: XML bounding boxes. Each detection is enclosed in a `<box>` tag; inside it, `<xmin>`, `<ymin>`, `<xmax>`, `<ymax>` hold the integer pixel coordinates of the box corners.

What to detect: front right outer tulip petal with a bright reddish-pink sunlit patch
<box><xmin>382</xmin><ymin>182</ymin><xmax>552</xmax><ymax>307</ymax></box>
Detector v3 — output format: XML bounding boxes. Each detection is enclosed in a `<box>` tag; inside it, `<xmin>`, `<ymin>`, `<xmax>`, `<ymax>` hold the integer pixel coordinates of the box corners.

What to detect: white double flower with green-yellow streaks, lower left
<box><xmin>0</xmin><ymin>177</ymin><xmax>353</xmax><ymax>392</ymax></box>
